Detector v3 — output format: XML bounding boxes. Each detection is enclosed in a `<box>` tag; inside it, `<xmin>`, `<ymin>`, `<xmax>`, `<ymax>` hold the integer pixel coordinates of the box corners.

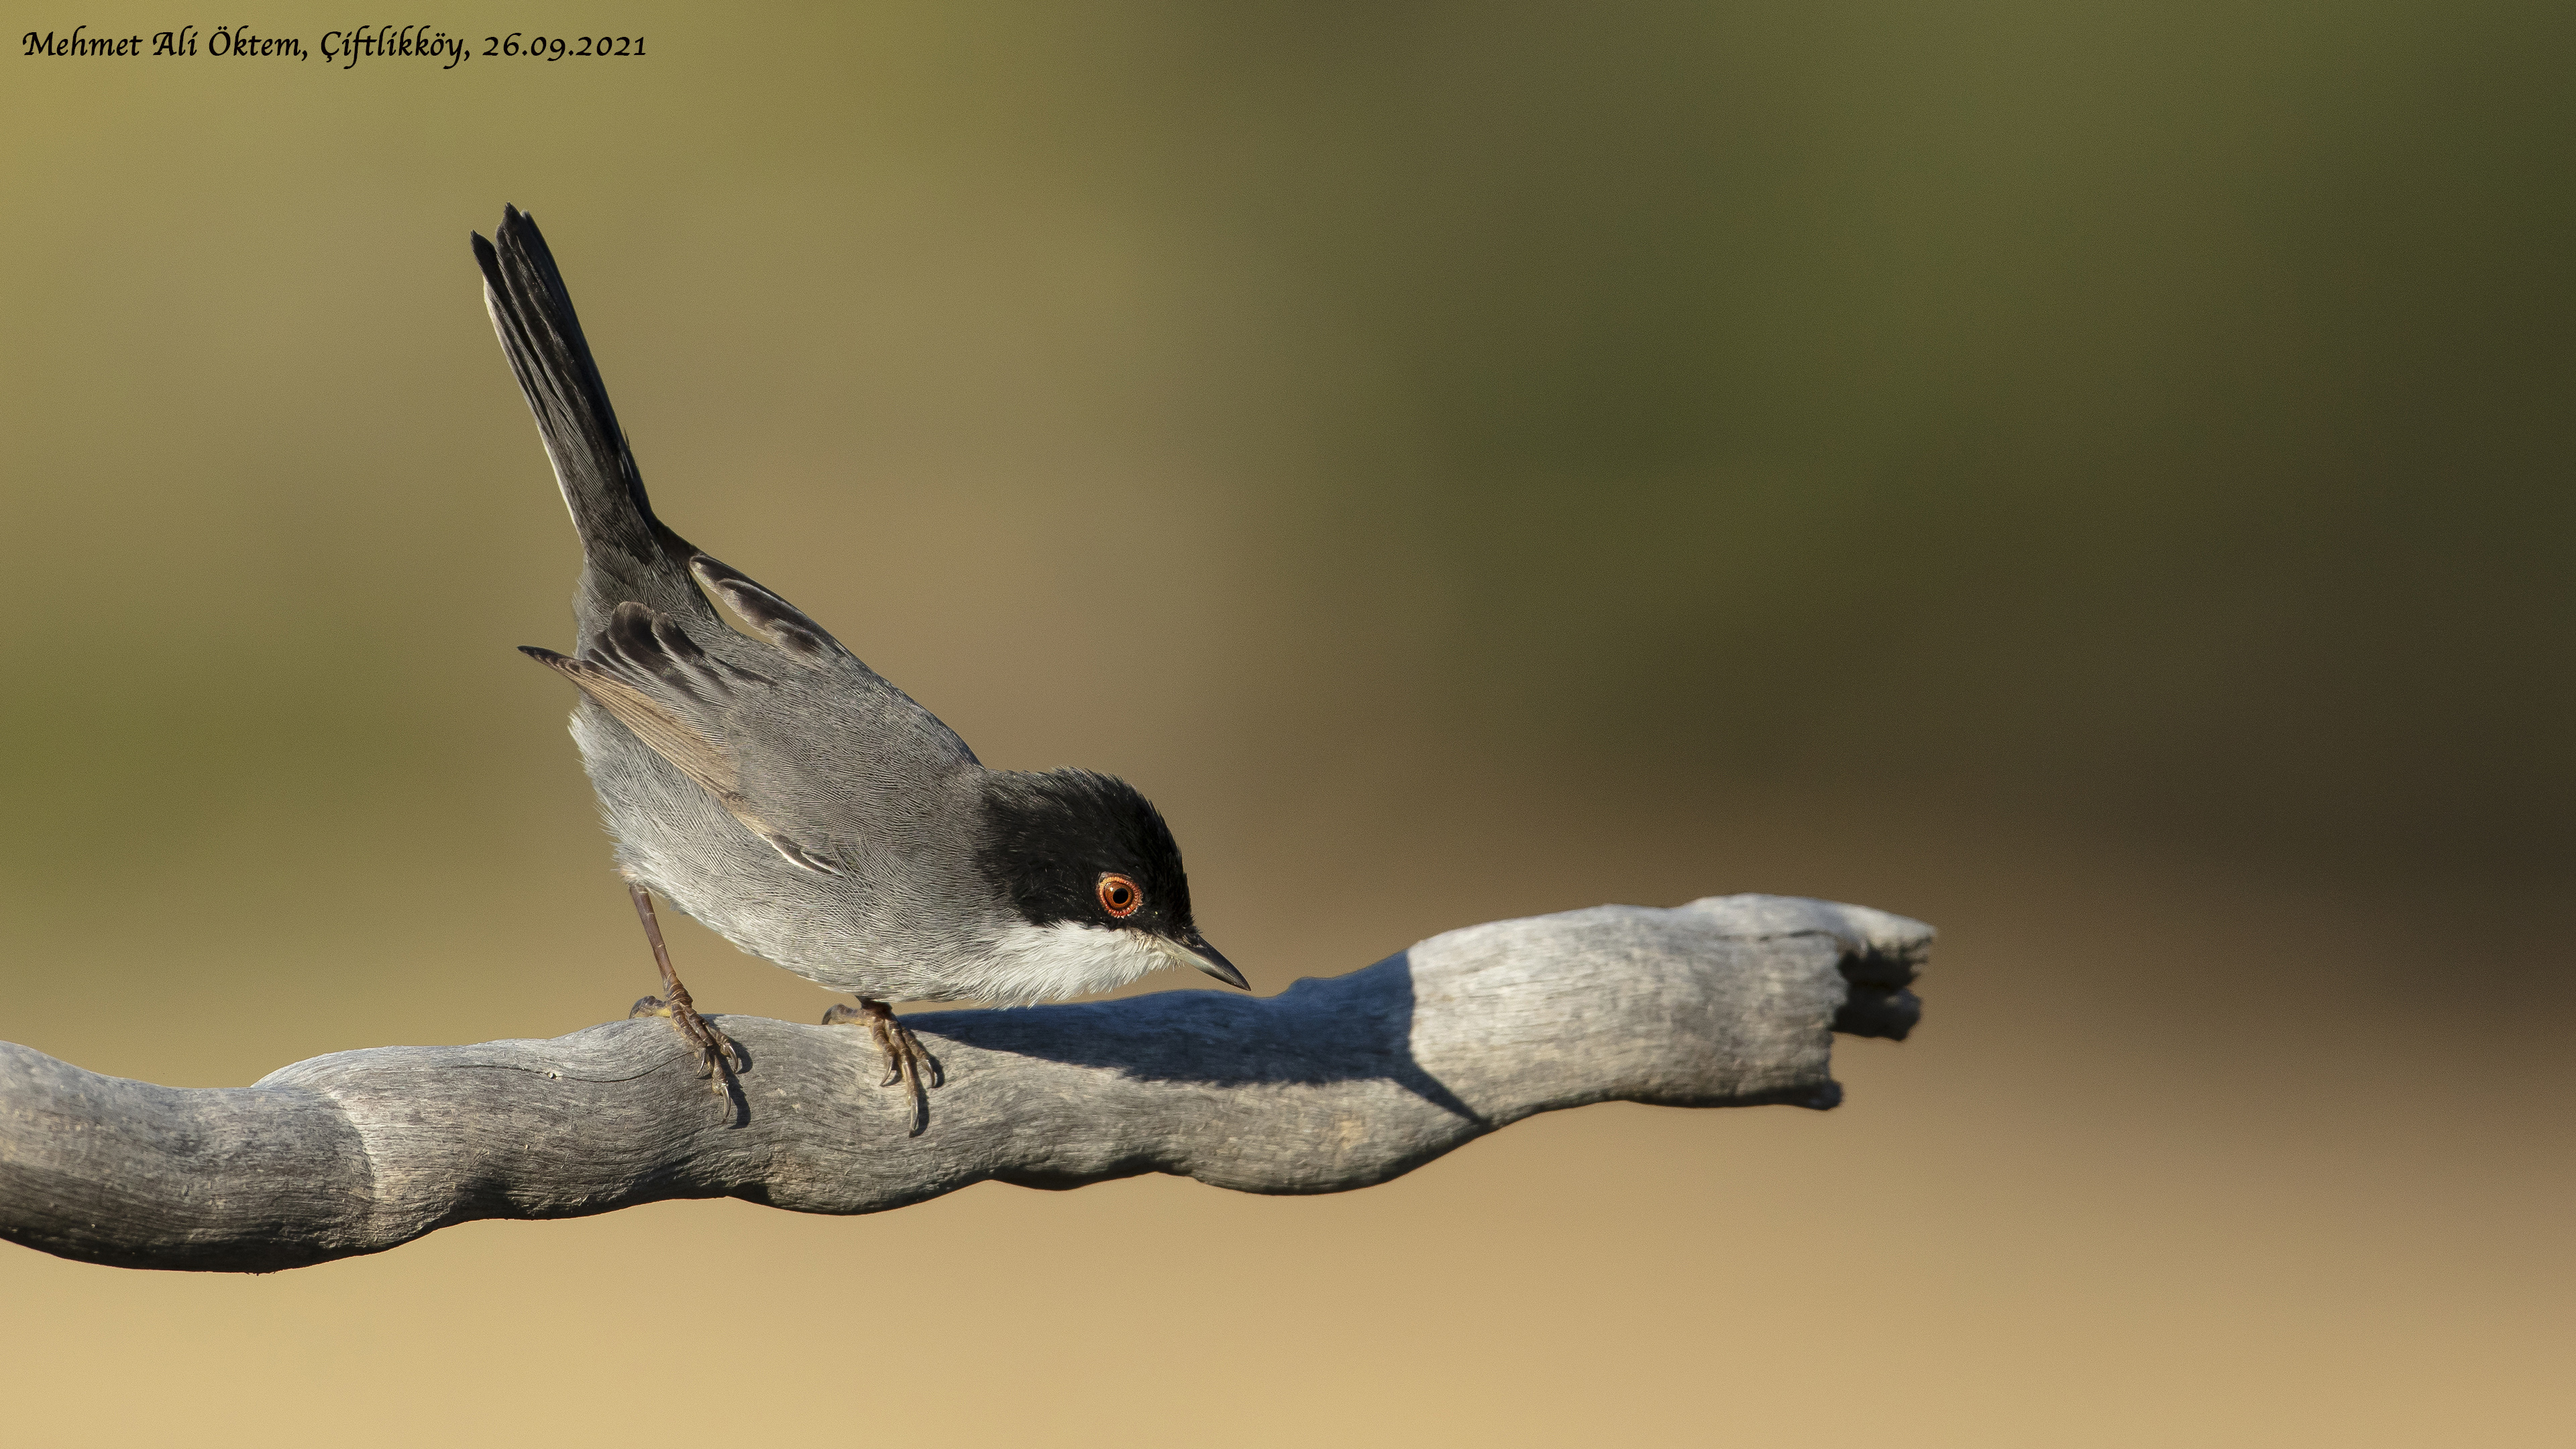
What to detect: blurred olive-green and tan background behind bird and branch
<box><xmin>0</xmin><ymin>0</ymin><xmax>2576</xmax><ymax>1446</ymax></box>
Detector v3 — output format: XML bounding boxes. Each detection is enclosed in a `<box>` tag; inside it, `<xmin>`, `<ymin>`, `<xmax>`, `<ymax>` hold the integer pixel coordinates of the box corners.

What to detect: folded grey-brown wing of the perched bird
<box><xmin>523</xmin><ymin>554</ymin><xmax>976</xmax><ymax>874</ymax></box>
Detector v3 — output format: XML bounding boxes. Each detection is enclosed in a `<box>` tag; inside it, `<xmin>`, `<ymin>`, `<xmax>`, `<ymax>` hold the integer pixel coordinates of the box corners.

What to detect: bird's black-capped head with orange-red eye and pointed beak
<box><xmin>976</xmin><ymin>771</ymin><xmax>1244</xmax><ymax>985</ymax></box>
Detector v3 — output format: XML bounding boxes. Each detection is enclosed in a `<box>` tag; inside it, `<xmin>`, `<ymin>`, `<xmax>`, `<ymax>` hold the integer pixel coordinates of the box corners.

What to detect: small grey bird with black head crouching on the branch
<box><xmin>474</xmin><ymin>206</ymin><xmax>1244</xmax><ymax>1134</ymax></box>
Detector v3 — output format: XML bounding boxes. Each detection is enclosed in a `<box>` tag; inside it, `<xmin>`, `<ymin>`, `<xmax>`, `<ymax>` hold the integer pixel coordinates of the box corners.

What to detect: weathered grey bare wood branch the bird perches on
<box><xmin>0</xmin><ymin>895</ymin><xmax>1932</xmax><ymax>1271</ymax></box>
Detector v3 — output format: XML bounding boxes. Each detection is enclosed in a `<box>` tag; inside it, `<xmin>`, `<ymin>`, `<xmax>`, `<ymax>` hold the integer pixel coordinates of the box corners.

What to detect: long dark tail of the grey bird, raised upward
<box><xmin>474</xmin><ymin>206</ymin><xmax>708</xmax><ymax>621</ymax></box>
